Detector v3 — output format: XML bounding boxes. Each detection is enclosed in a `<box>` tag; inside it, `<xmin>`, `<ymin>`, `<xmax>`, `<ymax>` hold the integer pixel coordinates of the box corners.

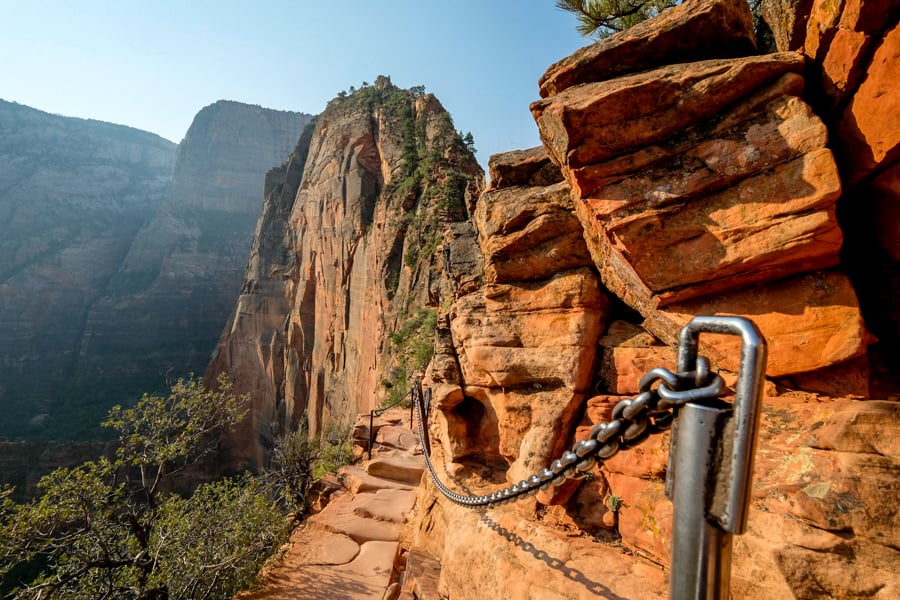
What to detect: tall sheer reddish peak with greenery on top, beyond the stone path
<box><xmin>207</xmin><ymin>78</ymin><xmax>482</xmax><ymax>466</ymax></box>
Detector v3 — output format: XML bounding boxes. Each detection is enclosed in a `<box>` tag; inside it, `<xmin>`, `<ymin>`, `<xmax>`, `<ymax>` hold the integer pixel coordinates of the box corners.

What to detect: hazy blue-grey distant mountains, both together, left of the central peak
<box><xmin>0</xmin><ymin>101</ymin><xmax>311</xmax><ymax>439</ymax></box>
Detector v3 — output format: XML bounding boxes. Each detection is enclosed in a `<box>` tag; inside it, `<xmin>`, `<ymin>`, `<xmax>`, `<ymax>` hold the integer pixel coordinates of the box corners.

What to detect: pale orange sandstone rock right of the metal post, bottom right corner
<box><xmin>733</xmin><ymin>401</ymin><xmax>900</xmax><ymax>598</ymax></box>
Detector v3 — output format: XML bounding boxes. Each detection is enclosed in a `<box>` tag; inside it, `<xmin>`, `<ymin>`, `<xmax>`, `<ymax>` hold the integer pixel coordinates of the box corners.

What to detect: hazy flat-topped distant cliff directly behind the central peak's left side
<box><xmin>79</xmin><ymin>101</ymin><xmax>311</xmax><ymax>422</ymax></box>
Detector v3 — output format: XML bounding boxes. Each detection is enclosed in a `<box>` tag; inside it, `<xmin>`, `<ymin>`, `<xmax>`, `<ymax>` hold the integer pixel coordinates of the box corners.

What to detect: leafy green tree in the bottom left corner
<box><xmin>0</xmin><ymin>378</ymin><xmax>287</xmax><ymax>600</ymax></box>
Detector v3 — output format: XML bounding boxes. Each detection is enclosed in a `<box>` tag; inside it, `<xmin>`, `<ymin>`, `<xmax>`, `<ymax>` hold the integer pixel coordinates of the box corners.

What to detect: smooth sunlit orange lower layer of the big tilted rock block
<box><xmin>586</xmin><ymin>148</ymin><xmax>842</xmax><ymax>305</ymax></box>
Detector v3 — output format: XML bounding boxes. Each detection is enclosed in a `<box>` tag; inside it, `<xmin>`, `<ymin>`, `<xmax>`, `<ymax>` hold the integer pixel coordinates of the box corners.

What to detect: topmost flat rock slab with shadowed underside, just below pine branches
<box><xmin>539</xmin><ymin>0</ymin><xmax>756</xmax><ymax>98</ymax></box>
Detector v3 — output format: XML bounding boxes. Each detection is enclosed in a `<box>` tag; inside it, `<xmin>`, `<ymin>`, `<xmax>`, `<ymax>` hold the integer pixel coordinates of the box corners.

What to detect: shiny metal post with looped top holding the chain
<box><xmin>666</xmin><ymin>317</ymin><xmax>766</xmax><ymax>600</ymax></box>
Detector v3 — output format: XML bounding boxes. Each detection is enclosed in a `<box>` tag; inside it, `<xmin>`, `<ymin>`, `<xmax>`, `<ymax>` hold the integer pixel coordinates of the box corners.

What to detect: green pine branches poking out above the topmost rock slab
<box><xmin>556</xmin><ymin>0</ymin><xmax>682</xmax><ymax>39</ymax></box>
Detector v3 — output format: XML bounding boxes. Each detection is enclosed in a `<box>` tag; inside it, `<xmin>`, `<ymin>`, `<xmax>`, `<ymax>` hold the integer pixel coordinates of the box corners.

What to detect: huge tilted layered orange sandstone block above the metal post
<box><xmin>532</xmin><ymin>44</ymin><xmax>868</xmax><ymax>384</ymax></box>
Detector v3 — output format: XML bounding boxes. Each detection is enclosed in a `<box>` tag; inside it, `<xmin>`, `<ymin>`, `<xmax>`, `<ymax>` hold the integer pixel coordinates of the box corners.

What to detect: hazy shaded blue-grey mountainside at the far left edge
<box><xmin>0</xmin><ymin>101</ymin><xmax>175</xmax><ymax>438</ymax></box>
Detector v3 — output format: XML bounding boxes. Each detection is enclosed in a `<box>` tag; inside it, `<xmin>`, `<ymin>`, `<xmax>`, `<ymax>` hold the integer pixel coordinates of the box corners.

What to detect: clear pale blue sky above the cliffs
<box><xmin>0</xmin><ymin>0</ymin><xmax>590</xmax><ymax>170</ymax></box>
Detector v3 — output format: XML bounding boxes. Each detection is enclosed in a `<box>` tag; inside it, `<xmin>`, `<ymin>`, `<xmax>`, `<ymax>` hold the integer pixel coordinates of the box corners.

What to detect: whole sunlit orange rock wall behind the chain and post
<box><xmin>410</xmin><ymin>0</ymin><xmax>900</xmax><ymax>599</ymax></box>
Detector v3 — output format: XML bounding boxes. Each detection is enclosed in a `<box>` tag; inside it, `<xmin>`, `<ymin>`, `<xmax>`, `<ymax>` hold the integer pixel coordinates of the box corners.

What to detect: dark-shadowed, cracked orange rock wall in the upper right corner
<box><xmin>763</xmin><ymin>0</ymin><xmax>900</xmax><ymax>395</ymax></box>
